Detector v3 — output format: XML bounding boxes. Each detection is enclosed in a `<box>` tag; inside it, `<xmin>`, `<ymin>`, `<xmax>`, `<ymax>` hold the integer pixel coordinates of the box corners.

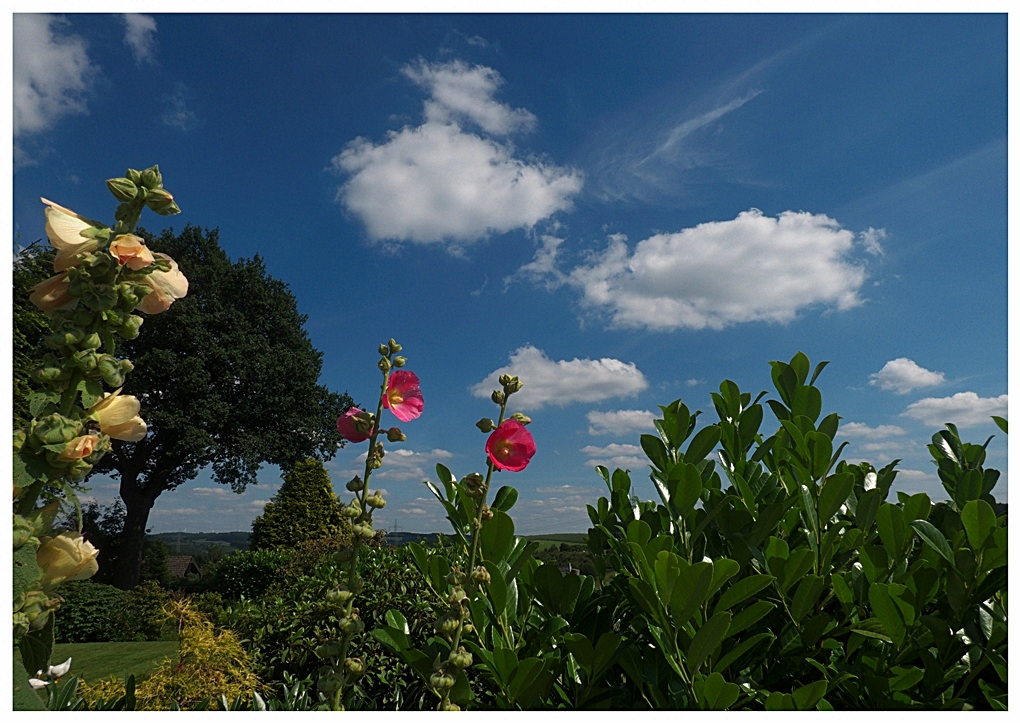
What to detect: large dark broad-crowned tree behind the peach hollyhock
<box><xmin>94</xmin><ymin>225</ymin><xmax>352</xmax><ymax>589</ymax></box>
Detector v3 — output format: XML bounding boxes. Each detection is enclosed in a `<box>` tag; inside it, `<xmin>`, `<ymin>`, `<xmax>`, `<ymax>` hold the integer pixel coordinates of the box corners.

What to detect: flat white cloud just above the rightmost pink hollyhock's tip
<box><xmin>471</xmin><ymin>345</ymin><xmax>648</xmax><ymax>409</ymax></box>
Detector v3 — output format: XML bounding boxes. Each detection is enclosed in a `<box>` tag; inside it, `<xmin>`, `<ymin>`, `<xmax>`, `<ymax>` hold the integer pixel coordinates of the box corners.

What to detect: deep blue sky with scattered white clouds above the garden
<box><xmin>13</xmin><ymin>14</ymin><xmax>1008</xmax><ymax>533</ymax></box>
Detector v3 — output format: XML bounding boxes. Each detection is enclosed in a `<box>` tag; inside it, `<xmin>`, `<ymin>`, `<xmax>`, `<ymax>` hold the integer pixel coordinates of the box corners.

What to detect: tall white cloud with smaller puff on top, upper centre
<box><xmin>333</xmin><ymin>60</ymin><xmax>582</xmax><ymax>245</ymax></box>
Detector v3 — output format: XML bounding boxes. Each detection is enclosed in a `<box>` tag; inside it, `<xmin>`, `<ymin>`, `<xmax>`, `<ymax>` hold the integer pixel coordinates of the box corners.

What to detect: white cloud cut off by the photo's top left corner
<box><xmin>13</xmin><ymin>13</ymin><xmax>99</xmax><ymax>138</ymax></box>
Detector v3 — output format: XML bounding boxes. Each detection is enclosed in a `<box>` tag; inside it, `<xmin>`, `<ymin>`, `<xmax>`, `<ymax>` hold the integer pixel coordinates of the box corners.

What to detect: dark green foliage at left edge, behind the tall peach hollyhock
<box><xmin>12</xmin><ymin>241</ymin><xmax>56</xmax><ymax>429</ymax></box>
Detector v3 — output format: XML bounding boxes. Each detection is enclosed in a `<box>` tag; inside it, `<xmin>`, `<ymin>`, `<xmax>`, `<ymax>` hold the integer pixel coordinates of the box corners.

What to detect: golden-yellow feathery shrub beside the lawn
<box><xmin>81</xmin><ymin>599</ymin><xmax>266</xmax><ymax>711</ymax></box>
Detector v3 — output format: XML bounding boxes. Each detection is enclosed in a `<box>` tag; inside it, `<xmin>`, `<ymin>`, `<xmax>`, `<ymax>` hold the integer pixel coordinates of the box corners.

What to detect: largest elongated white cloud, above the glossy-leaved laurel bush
<box><xmin>568</xmin><ymin>209</ymin><xmax>866</xmax><ymax>331</ymax></box>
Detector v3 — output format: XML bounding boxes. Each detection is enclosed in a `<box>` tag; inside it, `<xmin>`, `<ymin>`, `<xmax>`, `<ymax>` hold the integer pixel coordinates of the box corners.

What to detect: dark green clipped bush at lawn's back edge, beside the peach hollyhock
<box><xmin>54</xmin><ymin>580</ymin><xmax>126</xmax><ymax>642</ymax></box>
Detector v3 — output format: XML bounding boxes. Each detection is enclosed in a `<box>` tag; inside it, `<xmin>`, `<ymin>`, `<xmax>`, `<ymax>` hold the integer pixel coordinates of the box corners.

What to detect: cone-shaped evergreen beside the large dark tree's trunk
<box><xmin>250</xmin><ymin>459</ymin><xmax>351</xmax><ymax>550</ymax></box>
